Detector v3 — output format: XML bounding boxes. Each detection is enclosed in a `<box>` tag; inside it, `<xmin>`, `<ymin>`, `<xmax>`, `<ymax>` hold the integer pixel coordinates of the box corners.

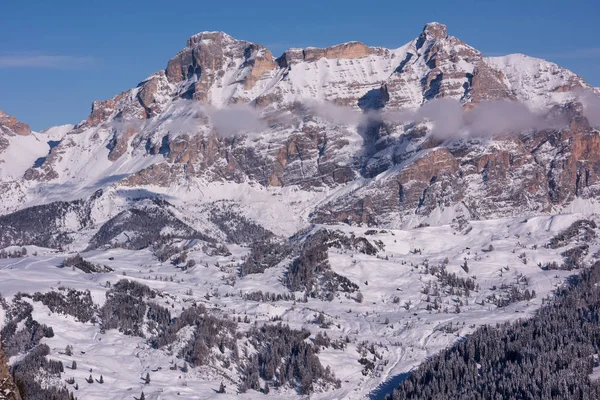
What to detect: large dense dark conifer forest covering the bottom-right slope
<box><xmin>392</xmin><ymin>263</ymin><xmax>600</xmax><ymax>400</ymax></box>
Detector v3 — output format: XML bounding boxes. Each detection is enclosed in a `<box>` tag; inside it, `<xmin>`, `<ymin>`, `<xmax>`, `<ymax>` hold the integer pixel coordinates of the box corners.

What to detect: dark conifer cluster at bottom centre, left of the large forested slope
<box><xmin>240</xmin><ymin>323</ymin><xmax>340</xmax><ymax>394</ymax></box>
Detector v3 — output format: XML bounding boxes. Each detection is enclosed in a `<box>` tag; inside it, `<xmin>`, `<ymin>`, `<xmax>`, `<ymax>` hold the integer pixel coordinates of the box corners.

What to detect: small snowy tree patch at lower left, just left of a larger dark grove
<box><xmin>32</xmin><ymin>288</ymin><xmax>98</xmax><ymax>322</ymax></box>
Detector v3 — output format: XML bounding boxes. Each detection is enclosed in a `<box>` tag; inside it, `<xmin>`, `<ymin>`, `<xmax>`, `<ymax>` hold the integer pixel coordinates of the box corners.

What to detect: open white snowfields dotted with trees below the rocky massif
<box><xmin>0</xmin><ymin>215</ymin><xmax>600</xmax><ymax>399</ymax></box>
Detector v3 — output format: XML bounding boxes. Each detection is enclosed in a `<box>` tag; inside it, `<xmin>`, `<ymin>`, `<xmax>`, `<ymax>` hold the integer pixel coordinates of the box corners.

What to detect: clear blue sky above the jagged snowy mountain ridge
<box><xmin>0</xmin><ymin>0</ymin><xmax>600</xmax><ymax>130</ymax></box>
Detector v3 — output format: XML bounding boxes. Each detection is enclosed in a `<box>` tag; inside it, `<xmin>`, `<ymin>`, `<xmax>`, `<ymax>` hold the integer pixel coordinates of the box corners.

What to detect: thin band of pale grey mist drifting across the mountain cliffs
<box><xmin>111</xmin><ymin>91</ymin><xmax>600</xmax><ymax>139</ymax></box>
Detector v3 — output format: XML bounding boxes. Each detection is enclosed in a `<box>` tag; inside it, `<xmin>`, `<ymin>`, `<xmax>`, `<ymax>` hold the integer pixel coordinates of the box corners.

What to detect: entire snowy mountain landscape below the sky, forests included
<box><xmin>0</xmin><ymin>23</ymin><xmax>600</xmax><ymax>400</ymax></box>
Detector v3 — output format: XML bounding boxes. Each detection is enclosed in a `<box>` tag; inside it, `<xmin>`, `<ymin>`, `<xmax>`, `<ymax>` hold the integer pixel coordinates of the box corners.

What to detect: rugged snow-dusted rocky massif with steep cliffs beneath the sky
<box><xmin>0</xmin><ymin>23</ymin><xmax>600</xmax><ymax>226</ymax></box>
